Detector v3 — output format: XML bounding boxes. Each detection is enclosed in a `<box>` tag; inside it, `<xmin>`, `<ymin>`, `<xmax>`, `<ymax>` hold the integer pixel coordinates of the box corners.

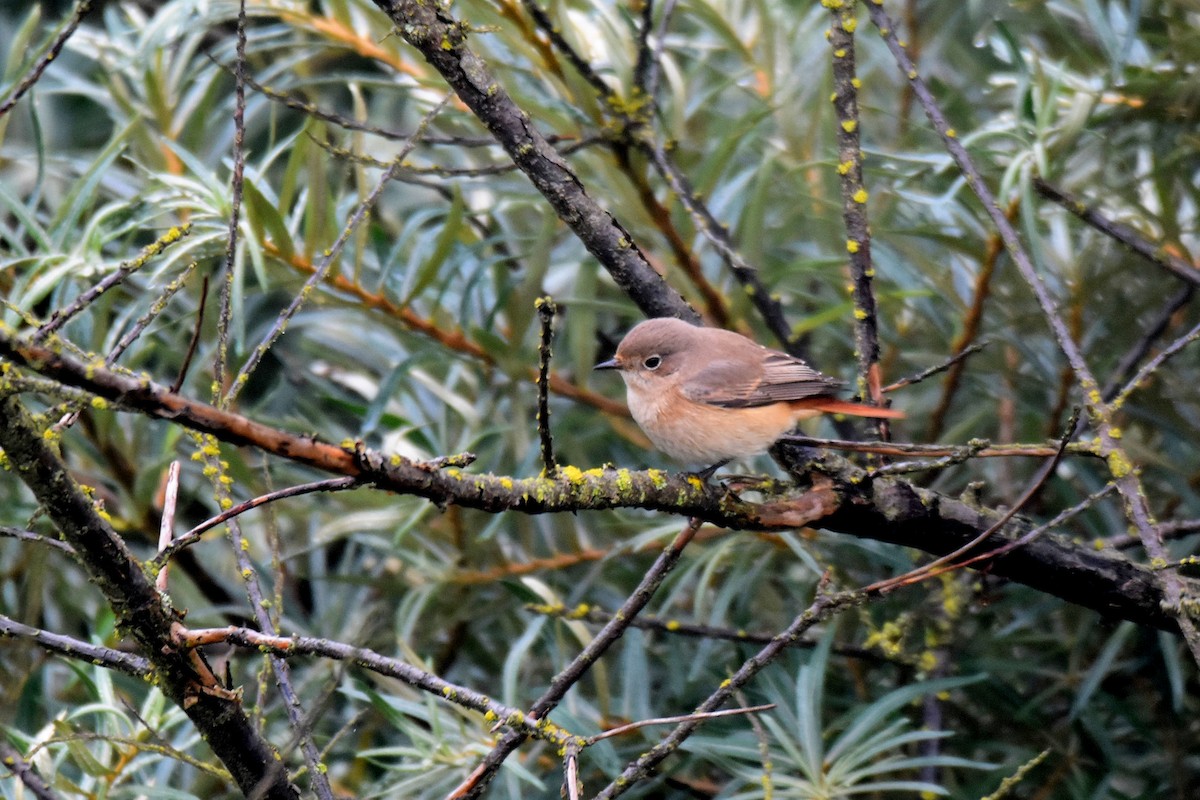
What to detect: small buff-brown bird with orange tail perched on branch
<box><xmin>595</xmin><ymin>317</ymin><xmax>904</xmax><ymax>476</ymax></box>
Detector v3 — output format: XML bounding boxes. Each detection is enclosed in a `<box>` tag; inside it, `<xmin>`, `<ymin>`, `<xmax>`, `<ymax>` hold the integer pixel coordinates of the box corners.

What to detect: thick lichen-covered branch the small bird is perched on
<box><xmin>0</xmin><ymin>329</ymin><xmax>1178</xmax><ymax>631</ymax></box>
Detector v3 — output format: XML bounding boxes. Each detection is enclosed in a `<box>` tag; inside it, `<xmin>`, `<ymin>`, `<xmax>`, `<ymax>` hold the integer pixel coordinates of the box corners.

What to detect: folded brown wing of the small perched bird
<box><xmin>683</xmin><ymin>350</ymin><xmax>841</xmax><ymax>408</ymax></box>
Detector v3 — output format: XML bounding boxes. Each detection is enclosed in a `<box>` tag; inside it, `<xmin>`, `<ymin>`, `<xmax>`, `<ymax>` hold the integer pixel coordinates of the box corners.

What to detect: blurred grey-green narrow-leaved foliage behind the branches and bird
<box><xmin>0</xmin><ymin>0</ymin><xmax>1200</xmax><ymax>799</ymax></box>
